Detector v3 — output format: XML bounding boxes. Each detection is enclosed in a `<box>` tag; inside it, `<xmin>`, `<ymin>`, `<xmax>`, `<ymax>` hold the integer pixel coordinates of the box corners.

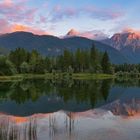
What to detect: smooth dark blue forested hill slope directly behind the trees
<box><xmin>0</xmin><ymin>32</ymin><xmax>128</xmax><ymax>63</ymax></box>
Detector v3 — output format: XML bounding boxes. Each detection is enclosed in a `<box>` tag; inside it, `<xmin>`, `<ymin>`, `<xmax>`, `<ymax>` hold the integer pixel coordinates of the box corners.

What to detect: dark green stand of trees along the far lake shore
<box><xmin>0</xmin><ymin>44</ymin><xmax>113</xmax><ymax>75</ymax></box>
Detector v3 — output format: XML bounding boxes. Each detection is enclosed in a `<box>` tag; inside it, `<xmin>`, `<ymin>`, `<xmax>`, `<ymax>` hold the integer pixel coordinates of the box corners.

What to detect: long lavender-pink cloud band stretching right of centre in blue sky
<box><xmin>52</xmin><ymin>5</ymin><xmax>124</xmax><ymax>21</ymax></box>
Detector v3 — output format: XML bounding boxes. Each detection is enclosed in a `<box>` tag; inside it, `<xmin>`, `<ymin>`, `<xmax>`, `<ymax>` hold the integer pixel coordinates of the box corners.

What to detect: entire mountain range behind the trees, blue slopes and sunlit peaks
<box><xmin>0</xmin><ymin>30</ymin><xmax>140</xmax><ymax>64</ymax></box>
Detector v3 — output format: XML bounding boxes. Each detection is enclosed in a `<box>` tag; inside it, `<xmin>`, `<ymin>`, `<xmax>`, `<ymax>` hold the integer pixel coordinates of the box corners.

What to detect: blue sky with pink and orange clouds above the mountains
<box><xmin>0</xmin><ymin>0</ymin><xmax>140</xmax><ymax>38</ymax></box>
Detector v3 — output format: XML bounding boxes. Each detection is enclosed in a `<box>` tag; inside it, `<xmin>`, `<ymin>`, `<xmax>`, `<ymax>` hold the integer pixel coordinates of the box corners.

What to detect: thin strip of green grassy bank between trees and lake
<box><xmin>0</xmin><ymin>73</ymin><xmax>115</xmax><ymax>82</ymax></box>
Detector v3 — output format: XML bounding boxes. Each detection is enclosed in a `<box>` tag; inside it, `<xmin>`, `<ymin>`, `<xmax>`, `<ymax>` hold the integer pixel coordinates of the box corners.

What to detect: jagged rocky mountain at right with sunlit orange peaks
<box><xmin>102</xmin><ymin>32</ymin><xmax>140</xmax><ymax>63</ymax></box>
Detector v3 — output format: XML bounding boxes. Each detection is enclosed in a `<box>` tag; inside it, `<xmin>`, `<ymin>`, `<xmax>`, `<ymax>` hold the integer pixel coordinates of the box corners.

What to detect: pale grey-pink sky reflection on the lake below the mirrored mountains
<box><xmin>0</xmin><ymin>109</ymin><xmax>140</xmax><ymax>140</ymax></box>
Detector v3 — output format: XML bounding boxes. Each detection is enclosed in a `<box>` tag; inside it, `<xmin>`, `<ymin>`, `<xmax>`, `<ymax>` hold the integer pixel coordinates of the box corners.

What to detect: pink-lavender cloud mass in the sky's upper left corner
<box><xmin>0</xmin><ymin>0</ymin><xmax>37</xmax><ymax>23</ymax></box>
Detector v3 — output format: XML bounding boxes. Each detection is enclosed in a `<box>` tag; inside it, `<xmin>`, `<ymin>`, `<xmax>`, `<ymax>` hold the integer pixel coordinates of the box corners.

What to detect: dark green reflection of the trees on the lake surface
<box><xmin>0</xmin><ymin>79</ymin><xmax>112</xmax><ymax>113</ymax></box>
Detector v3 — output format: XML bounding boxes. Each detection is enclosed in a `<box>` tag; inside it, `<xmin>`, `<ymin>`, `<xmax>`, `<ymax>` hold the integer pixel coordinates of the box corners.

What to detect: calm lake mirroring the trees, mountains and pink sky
<box><xmin>0</xmin><ymin>79</ymin><xmax>140</xmax><ymax>140</ymax></box>
